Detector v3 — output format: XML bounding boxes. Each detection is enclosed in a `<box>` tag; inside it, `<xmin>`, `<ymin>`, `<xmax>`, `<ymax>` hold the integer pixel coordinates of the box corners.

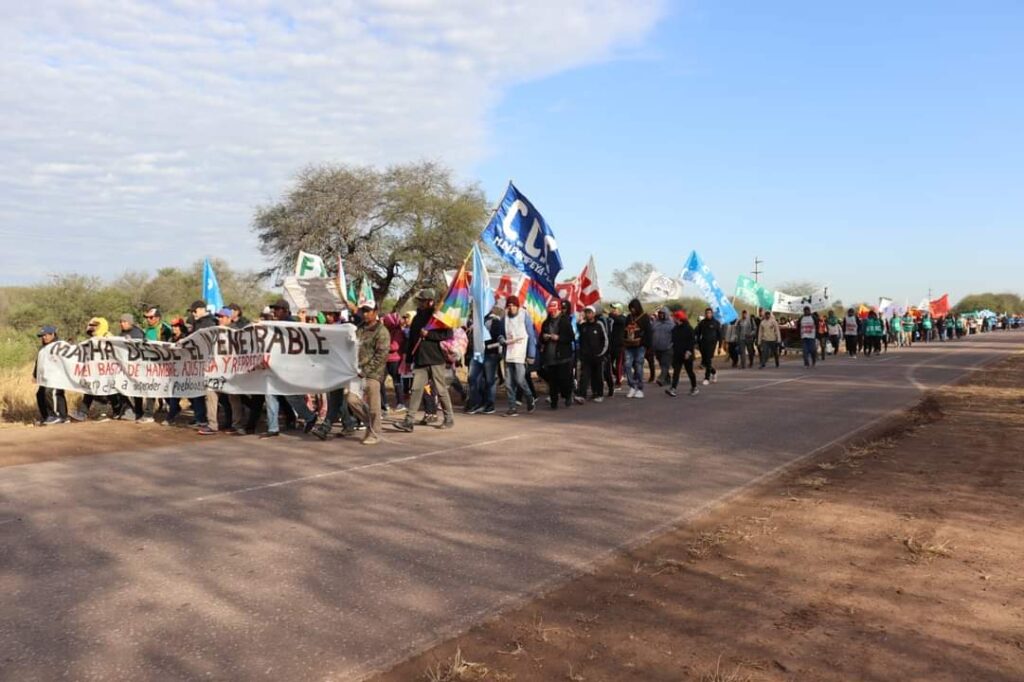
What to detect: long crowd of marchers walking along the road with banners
<box><xmin>34</xmin><ymin>289</ymin><xmax>1018</xmax><ymax>444</ymax></box>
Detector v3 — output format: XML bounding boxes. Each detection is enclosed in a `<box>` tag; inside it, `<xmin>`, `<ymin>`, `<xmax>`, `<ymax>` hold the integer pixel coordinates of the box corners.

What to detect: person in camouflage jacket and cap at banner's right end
<box><xmin>347</xmin><ymin>301</ymin><xmax>391</xmax><ymax>445</ymax></box>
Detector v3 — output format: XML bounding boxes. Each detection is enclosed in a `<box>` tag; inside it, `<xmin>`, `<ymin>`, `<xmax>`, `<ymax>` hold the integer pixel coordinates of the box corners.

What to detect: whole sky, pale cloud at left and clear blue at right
<box><xmin>0</xmin><ymin>0</ymin><xmax>1024</xmax><ymax>301</ymax></box>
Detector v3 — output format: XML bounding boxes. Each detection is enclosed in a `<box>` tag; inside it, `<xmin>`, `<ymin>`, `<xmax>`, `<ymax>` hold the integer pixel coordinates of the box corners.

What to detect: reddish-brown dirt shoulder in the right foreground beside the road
<box><xmin>374</xmin><ymin>355</ymin><xmax>1024</xmax><ymax>682</ymax></box>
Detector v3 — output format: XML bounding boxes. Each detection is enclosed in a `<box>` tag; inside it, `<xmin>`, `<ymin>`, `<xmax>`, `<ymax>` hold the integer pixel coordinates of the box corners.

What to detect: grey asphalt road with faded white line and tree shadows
<box><xmin>0</xmin><ymin>332</ymin><xmax>1024</xmax><ymax>682</ymax></box>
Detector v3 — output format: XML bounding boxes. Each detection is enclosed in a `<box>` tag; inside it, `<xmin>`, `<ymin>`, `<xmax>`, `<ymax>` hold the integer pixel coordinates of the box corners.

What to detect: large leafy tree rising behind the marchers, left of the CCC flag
<box><xmin>253</xmin><ymin>162</ymin><xmax>487</xmax><ymax>306</ymax></box>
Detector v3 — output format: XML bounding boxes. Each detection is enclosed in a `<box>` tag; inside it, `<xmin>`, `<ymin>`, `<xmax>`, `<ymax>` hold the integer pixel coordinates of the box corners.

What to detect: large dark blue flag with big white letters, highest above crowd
<box><xmin>483</xmin><ymin>182</ymin><xmax>562</xmax><ymax>291</ymax></box>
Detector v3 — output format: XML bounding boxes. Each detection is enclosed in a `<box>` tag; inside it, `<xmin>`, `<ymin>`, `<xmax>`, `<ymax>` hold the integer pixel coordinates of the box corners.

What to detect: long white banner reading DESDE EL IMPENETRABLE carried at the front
<box><xmin>37</xmin><ymin>322</ymin><xmax>358</xmax><ymax>397</ymax></box>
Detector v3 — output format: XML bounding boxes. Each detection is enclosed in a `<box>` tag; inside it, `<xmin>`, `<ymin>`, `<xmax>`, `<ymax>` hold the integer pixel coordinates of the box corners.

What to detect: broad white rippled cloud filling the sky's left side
<box><xmin>0</xmin><ymin>0</ymin><xmax>663</xmax><ymax>278</ymax></box>
